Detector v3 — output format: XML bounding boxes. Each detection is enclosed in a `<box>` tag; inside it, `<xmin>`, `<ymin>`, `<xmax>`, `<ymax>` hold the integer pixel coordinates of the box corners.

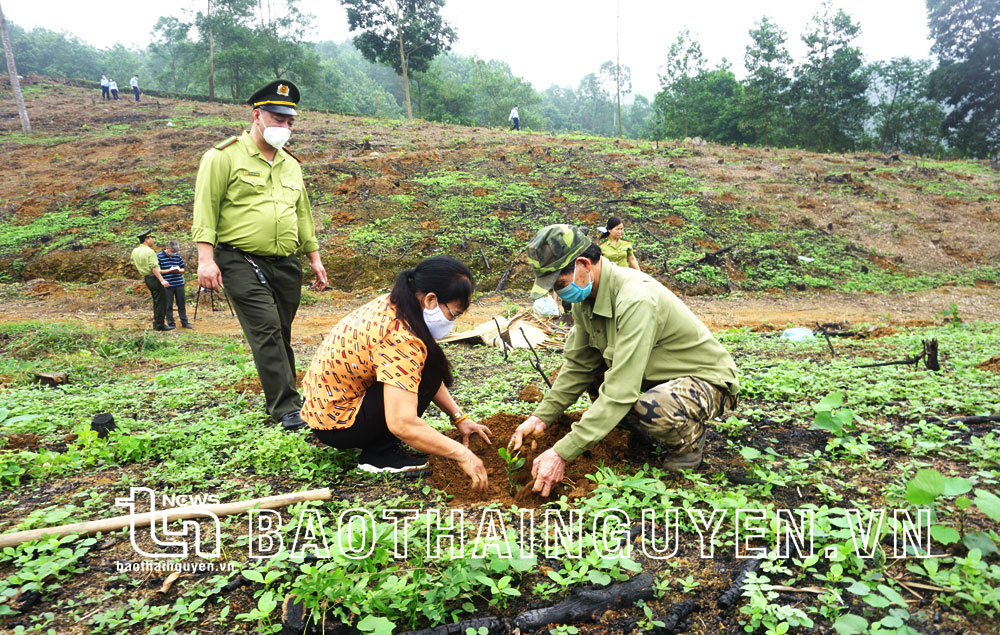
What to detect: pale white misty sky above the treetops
<box><xmin>3</xmin><ymin>0</ymin><xmax>931</xmax><ymax>97</ymax></box>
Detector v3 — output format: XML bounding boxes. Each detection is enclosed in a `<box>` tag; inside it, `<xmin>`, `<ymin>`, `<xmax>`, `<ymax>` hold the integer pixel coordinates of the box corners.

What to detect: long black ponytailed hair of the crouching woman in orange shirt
<box><xmin>389</xmin><ymin>256</ymin><xmax>476</xmax><ymax>387</ymax></box>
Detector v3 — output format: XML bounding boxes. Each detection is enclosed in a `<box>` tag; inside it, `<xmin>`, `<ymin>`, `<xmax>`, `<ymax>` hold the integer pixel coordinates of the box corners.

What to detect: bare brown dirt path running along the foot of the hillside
<box><xmin>0</xmin><ymin>281</ymin><xmax>1000</xmax><ymax>346</ymax></box>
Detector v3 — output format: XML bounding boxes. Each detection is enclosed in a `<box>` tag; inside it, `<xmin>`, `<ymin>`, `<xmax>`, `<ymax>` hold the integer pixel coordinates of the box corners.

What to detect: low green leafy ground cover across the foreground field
<box><xmin>0</xmin><ymin>316</ymin><xmax>1000</xmax><ymax>635</ymax></box>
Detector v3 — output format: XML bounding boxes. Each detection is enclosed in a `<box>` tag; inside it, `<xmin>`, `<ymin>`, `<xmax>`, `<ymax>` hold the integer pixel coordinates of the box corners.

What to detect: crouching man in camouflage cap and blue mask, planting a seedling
<box><xmin>510</xmin><ymin>225</ymin><xmax>740</xmax><ymax>496</ymax></box>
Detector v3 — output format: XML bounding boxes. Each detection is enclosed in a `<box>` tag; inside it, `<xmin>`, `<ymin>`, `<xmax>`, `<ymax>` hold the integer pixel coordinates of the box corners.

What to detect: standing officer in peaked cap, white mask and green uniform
<box><xmin>191</xmin><ymin>80</ymin><xmax>327</xmax><ymax>430</ymax></box>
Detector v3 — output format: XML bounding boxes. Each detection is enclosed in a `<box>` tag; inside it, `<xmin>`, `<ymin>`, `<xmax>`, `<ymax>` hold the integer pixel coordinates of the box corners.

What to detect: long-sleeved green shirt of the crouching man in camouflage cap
<box><xmin>534</xmin><ymin>258</ymin><xmax>740</xmax><ymax>461</ymax></box>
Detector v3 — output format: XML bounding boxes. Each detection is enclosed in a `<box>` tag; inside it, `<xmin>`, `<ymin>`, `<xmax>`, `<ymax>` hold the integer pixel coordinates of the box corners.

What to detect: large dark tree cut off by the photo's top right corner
<box><xmin>927</xmin><ymin>0</ymin><xmax>1000</xmax><ymax>156</ymax></box>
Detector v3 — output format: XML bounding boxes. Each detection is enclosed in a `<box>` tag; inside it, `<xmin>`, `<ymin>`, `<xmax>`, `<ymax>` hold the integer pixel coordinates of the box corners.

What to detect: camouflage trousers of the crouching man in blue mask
<box><xmin>590</xmin><ymin>375</ymin><xmax>737</xmax><ymax>455</ymax></box>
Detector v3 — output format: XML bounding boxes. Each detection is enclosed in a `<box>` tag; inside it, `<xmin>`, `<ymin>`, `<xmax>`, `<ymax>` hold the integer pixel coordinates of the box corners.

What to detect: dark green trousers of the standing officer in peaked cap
<box><xmin>221</xmin><ymin>249</ymin><xmax>302</xmax><ymax>420</ymax></box>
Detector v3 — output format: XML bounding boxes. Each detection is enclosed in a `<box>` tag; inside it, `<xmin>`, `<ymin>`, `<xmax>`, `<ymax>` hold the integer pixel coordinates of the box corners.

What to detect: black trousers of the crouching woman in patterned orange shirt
<box><xmin>312</xmin><ymin>365</ymin><xmax>442</xmax><ymax>453</ymax></box>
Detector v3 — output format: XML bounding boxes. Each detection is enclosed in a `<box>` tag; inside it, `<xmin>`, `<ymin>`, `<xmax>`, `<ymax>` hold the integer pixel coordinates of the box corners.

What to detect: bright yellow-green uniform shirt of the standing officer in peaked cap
<box><xmin>191</xmin><ymin>132</ymin><xmax>319</xmax><ymax>256</ymax></box>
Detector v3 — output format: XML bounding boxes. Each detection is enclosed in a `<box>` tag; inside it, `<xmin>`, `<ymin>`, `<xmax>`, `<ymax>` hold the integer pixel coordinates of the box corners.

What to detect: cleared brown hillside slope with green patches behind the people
<box><xmin>0</xmin><ymin>77</ymin><xmax>1000</xmax><ymax>293</ymax></box>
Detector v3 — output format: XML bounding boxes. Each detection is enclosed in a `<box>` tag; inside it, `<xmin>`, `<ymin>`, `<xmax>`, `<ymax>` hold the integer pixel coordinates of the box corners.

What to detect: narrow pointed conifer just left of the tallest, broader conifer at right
<box><xmin>739</xmin><ymin>16</ymin><xmax>792</xmax><ymax>145</ymax></box>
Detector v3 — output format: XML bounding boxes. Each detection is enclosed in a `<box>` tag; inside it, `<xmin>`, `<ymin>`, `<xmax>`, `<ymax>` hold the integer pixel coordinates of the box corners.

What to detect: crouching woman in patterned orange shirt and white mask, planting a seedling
<box><xmin>302</xmin><ymin>256</ymin><xmax>490</xmax><ymax>489</ymax></box>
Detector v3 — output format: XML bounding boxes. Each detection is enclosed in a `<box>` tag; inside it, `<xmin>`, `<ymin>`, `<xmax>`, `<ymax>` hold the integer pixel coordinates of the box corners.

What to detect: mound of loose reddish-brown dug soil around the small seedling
<box><xmin>429</xmin><ymin>412</ymin><xmax>629</xmax><ymax>507</ymax></box>
